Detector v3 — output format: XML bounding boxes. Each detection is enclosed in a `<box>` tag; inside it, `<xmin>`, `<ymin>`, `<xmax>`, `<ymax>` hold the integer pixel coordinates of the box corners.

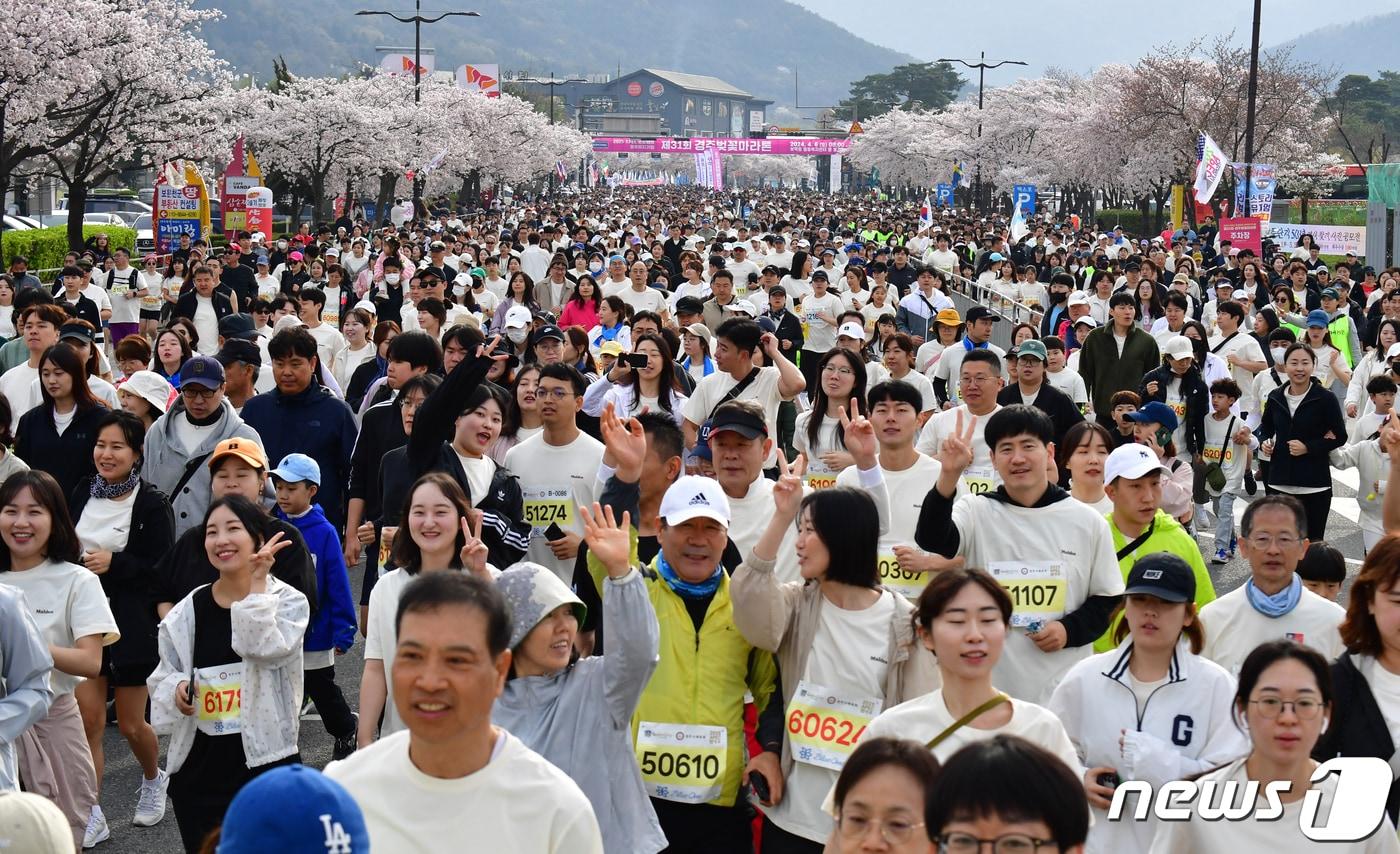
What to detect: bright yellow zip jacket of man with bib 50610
<box><xmin>588</xmin><ymin>546</ymin><xmax>777</xmax><ymax>806</ymax></box>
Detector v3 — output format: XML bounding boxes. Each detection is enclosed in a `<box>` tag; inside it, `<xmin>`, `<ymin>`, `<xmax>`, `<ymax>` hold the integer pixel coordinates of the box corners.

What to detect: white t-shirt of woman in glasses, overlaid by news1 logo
<box><xmin>1151</xmin><ymin>757</ymin><xmax>1400</xmax><ymax>854</ymax></box>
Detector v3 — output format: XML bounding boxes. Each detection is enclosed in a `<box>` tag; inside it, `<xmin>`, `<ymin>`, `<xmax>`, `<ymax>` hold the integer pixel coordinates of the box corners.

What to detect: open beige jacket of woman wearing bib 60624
<box><xmin>729</xmin><ymin>554</ymin><xmax>939</xmax><ymax>777</ymax></box>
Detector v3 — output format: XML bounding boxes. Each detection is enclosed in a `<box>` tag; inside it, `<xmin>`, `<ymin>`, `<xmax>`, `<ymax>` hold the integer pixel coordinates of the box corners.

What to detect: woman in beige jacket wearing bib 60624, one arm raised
<box><xmin>733</xmin><ymin>456</ymin><xmax>937</xmax><ymax>853</ymax></box>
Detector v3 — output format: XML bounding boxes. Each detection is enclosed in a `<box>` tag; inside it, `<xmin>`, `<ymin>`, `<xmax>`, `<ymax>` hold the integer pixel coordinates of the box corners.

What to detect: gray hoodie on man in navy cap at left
<box><xmin>141</xmin><ymin>398</ymin><xmax>262</xmax><ymax>539</ymax></box>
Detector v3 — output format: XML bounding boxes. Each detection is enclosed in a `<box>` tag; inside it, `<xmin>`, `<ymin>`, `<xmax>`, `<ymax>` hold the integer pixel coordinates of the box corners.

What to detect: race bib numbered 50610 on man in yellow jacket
<box><xmin>637</xmin><ymin>721</ymin><xmax>729</xmax><ymax>804</ymax></box>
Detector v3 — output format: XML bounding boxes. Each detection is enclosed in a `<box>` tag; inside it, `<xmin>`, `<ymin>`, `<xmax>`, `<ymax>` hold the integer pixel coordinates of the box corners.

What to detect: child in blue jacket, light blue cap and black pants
<box><xmin>269</xmin><ymin>454</ymin><xmax>358</xmax><ymax>759</ymax></box>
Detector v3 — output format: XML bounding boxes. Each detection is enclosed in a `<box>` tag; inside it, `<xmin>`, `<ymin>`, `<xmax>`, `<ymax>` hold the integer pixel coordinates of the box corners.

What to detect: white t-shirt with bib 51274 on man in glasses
<box><xmin>505</xmin><ymin>433</ymin><xmax>603</xmax><ymax>584</ymax></box>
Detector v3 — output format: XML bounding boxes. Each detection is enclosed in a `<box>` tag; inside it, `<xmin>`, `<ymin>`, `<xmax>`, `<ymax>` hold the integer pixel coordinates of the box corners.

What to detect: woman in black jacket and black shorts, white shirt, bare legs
<box><xmin>70</xmin><ymin>412</ymin><xmax>175</xmax><ymax>834</ymax></box>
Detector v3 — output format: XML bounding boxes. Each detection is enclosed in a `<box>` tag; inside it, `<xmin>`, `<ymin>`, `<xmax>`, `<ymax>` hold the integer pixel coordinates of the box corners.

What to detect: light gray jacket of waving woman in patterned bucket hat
<box><xmin>491</xmin><ymin>570</ymin><xmax>666</xmax><ymax>854</ymax></box>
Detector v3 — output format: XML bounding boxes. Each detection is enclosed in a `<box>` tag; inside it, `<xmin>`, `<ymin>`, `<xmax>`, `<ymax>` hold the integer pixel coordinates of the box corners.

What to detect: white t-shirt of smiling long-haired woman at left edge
<box><xmin>0</xmin><ymin>561</ymin><xmax>122</xmax><ymax>696</ymax></box>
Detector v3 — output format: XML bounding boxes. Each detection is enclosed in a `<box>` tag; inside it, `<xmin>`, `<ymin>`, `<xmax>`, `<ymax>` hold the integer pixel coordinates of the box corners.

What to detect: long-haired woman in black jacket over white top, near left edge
<box><xmin>14</xmin><ymin>342</ymin><xmax>108</xmax><ymax>496</ymax></box>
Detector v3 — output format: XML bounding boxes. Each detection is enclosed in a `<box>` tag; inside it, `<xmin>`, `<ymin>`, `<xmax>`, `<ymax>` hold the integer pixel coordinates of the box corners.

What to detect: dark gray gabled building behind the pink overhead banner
<box><xmin>522</xmin><ymin>69</ymin><xmax>773</xmax><ymax>137</ymax></box>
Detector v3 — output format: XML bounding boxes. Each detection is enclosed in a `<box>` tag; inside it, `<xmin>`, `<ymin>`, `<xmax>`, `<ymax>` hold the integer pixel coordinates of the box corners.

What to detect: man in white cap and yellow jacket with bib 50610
<box><xmin>588</xmin><ymin>475</ymin><xmax>781</xmax><ymax>853</ymax></box>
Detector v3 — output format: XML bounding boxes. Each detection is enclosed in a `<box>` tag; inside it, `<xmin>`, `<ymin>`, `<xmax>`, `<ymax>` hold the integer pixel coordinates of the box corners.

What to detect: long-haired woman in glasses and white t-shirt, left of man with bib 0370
<box><xmin>792</xmin><ymin>347</ymin><xmax>867</xmax><ymax>489</ymax></box>
